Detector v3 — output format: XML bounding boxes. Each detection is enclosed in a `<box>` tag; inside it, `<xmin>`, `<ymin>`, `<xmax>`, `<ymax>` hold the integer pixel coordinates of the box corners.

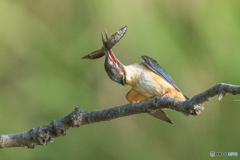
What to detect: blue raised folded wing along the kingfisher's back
<box><xmin>141</xmin><ymin>56</ymin><xmax>181</xmax><ymax>92</ymax></box>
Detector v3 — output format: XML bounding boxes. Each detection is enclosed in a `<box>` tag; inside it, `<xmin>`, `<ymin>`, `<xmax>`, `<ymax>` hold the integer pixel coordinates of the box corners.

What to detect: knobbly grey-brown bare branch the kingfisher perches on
<box><xmin>0</xmin><ymin>83</ymin><xmax>240</xmax><ymax>148</ymax></box>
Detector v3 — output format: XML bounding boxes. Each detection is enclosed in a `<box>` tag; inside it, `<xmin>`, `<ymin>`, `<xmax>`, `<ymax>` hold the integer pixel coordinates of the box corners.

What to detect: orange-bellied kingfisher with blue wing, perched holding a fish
<box><xmin>102</xmin><ymin>33</ymin><xmax>188</xmax><ymax>124</ymax></box>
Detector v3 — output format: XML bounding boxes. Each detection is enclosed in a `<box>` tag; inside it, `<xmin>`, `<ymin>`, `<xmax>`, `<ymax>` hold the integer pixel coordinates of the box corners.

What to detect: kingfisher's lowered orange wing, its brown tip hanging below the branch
<box><xmin>126</xmin><ymin>89</ymin><xmax>173</xmax><ymax>124</ymax></box>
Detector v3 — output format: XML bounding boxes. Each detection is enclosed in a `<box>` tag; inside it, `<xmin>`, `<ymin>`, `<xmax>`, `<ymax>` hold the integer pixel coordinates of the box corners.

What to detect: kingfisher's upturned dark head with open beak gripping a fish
<box><xmin>102</xmin><ymin>33</ymin><xmax>126</xmax><ymax>85</ymax></box>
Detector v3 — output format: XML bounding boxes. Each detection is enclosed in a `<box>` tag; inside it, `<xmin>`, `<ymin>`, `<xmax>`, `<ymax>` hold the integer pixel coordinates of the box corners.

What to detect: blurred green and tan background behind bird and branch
<box><xmin>0</xmin><ymin>0</ymin><xmax>240</xmax><ymax>160</ymax></box>
